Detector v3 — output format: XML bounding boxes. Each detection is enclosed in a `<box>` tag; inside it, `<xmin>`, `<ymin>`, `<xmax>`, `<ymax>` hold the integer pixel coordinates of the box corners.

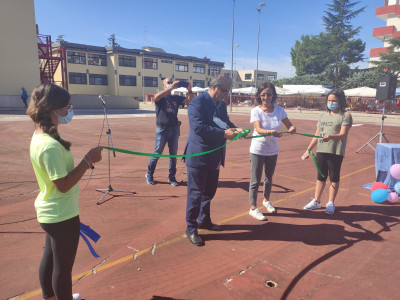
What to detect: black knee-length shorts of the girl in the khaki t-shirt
<box><xmin>317</xmin><ymin>152</ymin><xmax>343</xmax><ymax>182</ymax></box>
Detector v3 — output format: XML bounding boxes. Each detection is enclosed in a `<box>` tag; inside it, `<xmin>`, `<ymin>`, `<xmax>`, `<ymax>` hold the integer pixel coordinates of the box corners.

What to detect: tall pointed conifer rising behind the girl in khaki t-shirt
<box><xmin>322</xmin><ymin>0</ymin><xmax>365</xmax><ymax>87</ymax></box>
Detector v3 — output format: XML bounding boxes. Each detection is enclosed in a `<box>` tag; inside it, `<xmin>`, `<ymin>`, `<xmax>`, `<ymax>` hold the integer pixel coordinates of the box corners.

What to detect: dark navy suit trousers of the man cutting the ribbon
<box><xmin>186</xmin><ymin>167</ymin><xmax>219</xmax><ymax>233</ymax></box>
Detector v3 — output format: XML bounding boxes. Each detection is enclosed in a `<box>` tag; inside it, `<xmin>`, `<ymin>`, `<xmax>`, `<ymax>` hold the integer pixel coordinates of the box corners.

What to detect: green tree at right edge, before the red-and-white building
<box><xmin>370</xmin><ymin>37</ymin><xmax>400</xmax><ymax>78</ymax></box>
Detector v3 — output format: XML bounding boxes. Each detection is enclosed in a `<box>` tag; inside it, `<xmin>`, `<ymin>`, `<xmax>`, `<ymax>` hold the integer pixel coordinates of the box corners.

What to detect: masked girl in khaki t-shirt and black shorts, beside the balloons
<box><xmin>303</xmin><ymin>90</ymin><xmax>353</xmax><ymax>215</ymax></box>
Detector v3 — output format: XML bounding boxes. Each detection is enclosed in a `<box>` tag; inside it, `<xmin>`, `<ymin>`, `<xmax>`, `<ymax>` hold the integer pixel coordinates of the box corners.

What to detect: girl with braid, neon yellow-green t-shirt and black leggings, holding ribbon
<box><xmin>27</xmin><ymin>83</ymin><xmax>102</xmax><ymax>300</ymax></box>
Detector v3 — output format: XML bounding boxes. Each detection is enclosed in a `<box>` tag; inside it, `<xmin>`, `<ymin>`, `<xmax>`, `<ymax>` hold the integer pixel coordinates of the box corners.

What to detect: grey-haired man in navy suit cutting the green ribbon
<box><xmin>185</xmin><ymin>75</ymin><xmax>238</xmax><ymax>246</ymax></box>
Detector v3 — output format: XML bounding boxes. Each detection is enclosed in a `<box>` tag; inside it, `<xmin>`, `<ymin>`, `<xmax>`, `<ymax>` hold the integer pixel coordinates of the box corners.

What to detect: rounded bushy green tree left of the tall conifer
<box><xmin>290</xmin><ymin>32</ymin><xmax>330</xmax><ymax>76</ymax></box>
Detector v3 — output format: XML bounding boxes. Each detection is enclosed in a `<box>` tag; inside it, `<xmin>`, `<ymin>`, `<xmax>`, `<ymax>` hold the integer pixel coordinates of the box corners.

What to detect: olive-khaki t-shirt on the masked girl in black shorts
<box><xmin>317</xmin><ymin>112</ymin><xmax>353</xmax><ymax>157</ymax></box>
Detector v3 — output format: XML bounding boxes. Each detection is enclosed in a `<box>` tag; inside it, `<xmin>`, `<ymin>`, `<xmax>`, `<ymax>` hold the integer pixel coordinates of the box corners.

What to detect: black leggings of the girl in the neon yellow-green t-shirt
<box><xmin>39</xmin><ymin>216</ymin><xmax>80</xmax><ymax>300</ymax></box>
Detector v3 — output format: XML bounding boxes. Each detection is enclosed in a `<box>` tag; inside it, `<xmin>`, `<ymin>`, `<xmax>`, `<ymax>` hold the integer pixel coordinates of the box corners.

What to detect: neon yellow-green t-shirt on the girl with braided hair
<box><xmin>30</xmin><ymin>133</ymin><xmax>79</xmax><ymax>223</ymax></box>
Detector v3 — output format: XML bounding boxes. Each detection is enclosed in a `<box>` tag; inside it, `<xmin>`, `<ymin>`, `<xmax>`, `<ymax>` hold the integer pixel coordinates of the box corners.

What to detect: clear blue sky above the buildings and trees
<box><xmin>35</xmin><ymin>0</ymin><xmax>385</xmax><ymax>78</ymax></box>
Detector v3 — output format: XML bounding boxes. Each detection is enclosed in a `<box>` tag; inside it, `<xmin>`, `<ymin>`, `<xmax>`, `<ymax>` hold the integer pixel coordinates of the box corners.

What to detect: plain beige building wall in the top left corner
<box><xmin>0</xmin><ymin>0</ymin><xmax>40</xmax><ymax>96</ymax></box>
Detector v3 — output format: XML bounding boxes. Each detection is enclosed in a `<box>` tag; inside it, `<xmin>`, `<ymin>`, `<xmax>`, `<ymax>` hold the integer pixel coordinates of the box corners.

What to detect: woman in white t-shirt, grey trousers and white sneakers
<box><xmin>249</xmin><ymin>82</ymin><xmax>296</xmax><ymax>221</ymax></box>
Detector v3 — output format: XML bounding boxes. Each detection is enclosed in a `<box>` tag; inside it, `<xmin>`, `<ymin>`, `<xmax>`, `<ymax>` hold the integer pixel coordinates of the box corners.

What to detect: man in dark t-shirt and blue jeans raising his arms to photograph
<box><xmin>145</xmin><ymin>77</ymin><xmax>194</xmax><ymax>186</ymax></box>
